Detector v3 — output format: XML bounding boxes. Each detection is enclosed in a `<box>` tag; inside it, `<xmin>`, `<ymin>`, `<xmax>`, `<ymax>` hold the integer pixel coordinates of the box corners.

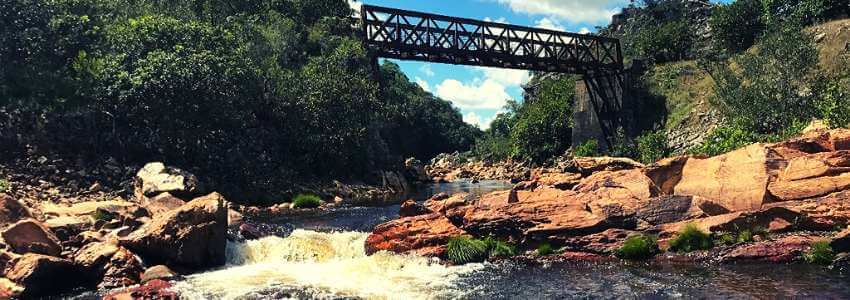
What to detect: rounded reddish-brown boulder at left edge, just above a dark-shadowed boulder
<box><xmin>2</xmin><ymin>219</ymin><xmax>62</xmax><ymax>256</ymax></box>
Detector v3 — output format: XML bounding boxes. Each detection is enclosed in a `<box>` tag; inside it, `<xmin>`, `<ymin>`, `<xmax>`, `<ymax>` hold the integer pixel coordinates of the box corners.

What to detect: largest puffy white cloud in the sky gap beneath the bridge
<box><xmin>436</xmin><ymin>79</ymin><xmax>511</xmax><ymax>109</ymax></box>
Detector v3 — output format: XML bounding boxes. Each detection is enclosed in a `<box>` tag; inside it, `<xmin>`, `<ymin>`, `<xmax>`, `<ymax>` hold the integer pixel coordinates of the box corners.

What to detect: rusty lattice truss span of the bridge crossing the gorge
<box><xmin>361</xmin><ymin>5</ymin><xmax>623</xmax><ymax>74</ymax></box>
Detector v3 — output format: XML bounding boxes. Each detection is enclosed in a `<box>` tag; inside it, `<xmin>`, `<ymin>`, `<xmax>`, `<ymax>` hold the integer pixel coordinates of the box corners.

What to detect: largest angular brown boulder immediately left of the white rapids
<box><xmin>121</xmin><ymin>193</ymin><xmax>227</xmax><ymax>270</ymax></box>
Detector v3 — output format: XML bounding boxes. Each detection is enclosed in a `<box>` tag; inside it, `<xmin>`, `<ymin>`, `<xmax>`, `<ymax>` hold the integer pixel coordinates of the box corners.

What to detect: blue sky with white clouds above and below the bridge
<box><xmin>348</xmin><ymin>0</ymin><xmax>724</xmax><ymax>129</ymax></box>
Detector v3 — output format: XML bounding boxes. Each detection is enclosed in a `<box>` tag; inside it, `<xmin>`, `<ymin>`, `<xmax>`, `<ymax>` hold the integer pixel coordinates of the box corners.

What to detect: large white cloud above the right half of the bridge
<box><xmin>495</xmin><ymin>0</ymin><xmax>629</xmax><ymax>24</ymax></box>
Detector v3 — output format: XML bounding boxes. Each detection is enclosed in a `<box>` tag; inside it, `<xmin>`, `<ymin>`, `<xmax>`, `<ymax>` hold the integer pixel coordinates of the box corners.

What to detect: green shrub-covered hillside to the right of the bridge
<box><xmin>476</xmin><ymin>0</ymin><xmax>850</xmax><ymax>163</ymax></box>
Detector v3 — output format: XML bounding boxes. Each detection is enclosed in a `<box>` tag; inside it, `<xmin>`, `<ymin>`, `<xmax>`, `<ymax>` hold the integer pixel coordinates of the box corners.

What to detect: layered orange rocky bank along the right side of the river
<box><xmin>366</xmin><ymin>129</ymin><xmax>850</xmax><ymax>268</ymax></box>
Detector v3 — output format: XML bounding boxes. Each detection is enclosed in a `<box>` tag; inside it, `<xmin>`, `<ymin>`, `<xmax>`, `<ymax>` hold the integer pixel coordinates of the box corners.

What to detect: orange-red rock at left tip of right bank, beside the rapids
<box><xmin>366</xmin><ymin>213</ymin><xmax>466</xmax><ymax>255</ymax></box>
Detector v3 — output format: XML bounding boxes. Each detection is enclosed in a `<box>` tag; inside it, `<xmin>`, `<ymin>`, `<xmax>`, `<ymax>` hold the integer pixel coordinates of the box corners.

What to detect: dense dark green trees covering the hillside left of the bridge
<box><xmin>0</xmin><ymin>0</ymin><xmax>480</xmax><ymax>202</ymax></box>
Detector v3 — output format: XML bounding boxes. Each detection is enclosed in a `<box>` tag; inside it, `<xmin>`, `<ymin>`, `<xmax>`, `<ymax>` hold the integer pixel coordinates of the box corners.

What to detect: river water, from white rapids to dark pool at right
<box><xmin>71</xmin><ymin>182</ymin><xmax>850</xmax><ymax>299</ymax></box>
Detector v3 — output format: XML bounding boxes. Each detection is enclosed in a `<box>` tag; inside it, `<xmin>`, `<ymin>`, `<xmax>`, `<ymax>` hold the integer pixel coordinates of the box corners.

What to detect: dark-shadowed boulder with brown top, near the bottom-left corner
<box><xmin>6</xmin><ymin>253</ymin><xmax>84</xmax><ymax>298</ymax></box>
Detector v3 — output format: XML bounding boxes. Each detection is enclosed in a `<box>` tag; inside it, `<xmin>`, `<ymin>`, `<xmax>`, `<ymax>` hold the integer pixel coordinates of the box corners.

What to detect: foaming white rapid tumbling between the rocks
<box><xmin>175</xmin><ymin>229</ymin><xmax>483</xmax><ymax>299</ymax></box>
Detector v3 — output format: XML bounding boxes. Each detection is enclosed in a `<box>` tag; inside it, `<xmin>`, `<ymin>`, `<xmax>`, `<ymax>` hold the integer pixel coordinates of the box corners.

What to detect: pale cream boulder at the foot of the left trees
<box><xmin>135</xmin><ymin>162</ymin><xmax>203</xmax><ymax>200</ymax></box>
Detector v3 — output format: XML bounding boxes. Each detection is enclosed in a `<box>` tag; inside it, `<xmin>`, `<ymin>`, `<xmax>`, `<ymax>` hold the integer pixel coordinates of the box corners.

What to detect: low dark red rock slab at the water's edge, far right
<box><xmin>722</xmin><ymin>235</ymin><xmax>817</xmax><ymax>263</ymax></box>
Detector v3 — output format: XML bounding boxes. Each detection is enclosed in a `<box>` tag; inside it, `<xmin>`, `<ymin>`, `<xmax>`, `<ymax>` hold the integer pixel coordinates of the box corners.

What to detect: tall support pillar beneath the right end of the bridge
<box><xmin>572</xmin><ymin>73</ymin><xmax>630</xmax><ymax>151</ymax></box>
